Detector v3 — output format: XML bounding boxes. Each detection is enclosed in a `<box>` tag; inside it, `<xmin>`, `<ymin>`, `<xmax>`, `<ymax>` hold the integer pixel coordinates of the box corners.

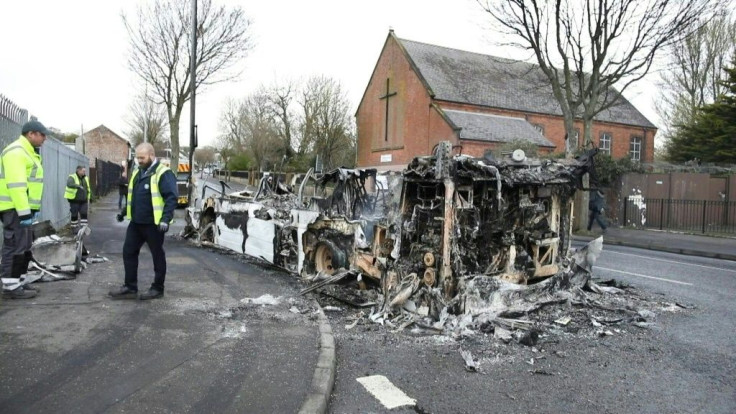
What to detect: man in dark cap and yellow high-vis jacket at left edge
<box><xmin>0</xmin><ymin>121</ymin><xmax>51</xmax><ymax>299</ymax></box>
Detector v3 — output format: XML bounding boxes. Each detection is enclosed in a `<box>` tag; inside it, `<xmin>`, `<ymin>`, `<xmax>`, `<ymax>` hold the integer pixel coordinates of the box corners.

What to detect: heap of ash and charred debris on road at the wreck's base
<box><xmin>306</xmin><ymin>238</ymin><xmax>689</xmax><ymax>346</ymax></box>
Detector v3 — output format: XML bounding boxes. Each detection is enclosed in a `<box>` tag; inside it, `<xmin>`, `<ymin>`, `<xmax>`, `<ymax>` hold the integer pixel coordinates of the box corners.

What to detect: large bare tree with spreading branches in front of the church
<box><xmin>477</xmin><ymin>0</ymin><xmax>720</xmax><ymax>154</ymax></box>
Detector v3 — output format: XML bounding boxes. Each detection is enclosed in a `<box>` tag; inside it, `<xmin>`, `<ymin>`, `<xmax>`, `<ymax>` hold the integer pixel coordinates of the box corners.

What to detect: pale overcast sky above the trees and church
<box><xmin>0</xmin><ymin>0</ymin><xmax>658</xmax><ymax>146</ymax></box>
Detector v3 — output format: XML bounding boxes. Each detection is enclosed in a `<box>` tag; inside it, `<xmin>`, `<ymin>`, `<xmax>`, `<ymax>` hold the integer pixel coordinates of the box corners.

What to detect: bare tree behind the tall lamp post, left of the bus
<box><xmin>122</xmin><ymin>0</ymin><xmax>251</xmax><ymax>165</ymax></box>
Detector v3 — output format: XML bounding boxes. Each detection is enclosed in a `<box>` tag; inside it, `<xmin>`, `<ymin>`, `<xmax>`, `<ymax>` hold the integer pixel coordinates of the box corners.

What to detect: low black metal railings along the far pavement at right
<box><xmin>623</xmin><ymin>197</ymin><xmax>736</xmax><ymax>234</ymax></box>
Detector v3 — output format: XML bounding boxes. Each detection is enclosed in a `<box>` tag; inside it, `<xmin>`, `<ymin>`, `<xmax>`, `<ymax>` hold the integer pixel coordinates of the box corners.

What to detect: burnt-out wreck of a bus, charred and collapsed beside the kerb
<box><xmin>185</xmin><ymin>142</ymin><xmax>672</xmax><ymax>342</ymax></box>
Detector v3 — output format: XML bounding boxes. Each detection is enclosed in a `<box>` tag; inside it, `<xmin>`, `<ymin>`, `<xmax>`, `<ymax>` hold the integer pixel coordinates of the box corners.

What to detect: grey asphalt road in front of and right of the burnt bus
<box><xmin>328</xmin><ymin>246</ymin><xmax>736</xmax><ymax>413</ymax></box>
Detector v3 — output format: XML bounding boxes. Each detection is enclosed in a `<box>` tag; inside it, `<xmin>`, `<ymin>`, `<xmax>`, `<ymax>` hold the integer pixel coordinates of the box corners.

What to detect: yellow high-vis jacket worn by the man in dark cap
<box><xmin>0</xmin><ymin>135</ymin><xmax>43</xmax><ymax>216</ymax></box>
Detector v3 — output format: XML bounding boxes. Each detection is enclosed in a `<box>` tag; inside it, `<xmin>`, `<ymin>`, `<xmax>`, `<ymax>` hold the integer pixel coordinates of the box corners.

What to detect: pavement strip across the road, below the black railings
<box><xmin>573</xmin><ymin>227</ymin><xmax>736</xmax><ymax>261</ymax></box>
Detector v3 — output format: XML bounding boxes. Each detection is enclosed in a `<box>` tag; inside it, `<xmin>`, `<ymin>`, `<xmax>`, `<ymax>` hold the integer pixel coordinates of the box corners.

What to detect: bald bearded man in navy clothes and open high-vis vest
<box><xmin>109</xmin><ymin>143</ymin><xmax>178</xmax><ymax>300</ymax></box>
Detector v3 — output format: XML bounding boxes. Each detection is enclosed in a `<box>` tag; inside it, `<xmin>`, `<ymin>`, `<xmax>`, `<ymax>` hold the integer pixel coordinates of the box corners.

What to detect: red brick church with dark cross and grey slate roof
<box><xmin>356</xmin><ymin>30</ymin><xmax>657</xmax><ymax>170</ymax></box>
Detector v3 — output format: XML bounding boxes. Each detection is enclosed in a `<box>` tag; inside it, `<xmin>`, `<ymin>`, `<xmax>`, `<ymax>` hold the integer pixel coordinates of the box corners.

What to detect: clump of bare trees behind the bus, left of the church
<box><xmin>218</xmin><ymin>76</ymin><xmax>356</xmax><ymax>169</ymax></box>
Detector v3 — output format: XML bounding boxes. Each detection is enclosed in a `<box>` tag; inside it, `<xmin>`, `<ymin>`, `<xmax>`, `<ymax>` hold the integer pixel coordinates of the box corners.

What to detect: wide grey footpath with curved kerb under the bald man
<box><xmin>0</xmin><ymin>194</ymin><xmax>335</xmax><ymax>413</ymax></box>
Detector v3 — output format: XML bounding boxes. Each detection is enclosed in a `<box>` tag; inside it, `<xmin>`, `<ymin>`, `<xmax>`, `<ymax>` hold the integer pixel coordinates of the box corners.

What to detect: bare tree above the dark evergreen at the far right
<box><xmin>657</xmin><ymin>11</ymin><xmax>736</xmax><ymax>142</ymax></box>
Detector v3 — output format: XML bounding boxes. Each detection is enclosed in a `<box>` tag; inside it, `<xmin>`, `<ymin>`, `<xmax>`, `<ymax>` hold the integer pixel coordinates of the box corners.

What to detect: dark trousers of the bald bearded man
<box><xmin>123</xmin><ymin>223</ymin><xmax>166</xmax><ymax>292</ymax></box>
